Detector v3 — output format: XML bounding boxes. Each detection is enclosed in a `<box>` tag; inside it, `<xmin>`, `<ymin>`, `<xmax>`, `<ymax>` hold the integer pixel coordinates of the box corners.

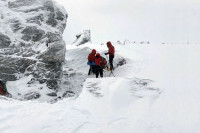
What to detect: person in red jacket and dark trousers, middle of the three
<box><xmin>95</xmin><ymin>53</ymin><xmax>103</xmax><ymax>78</ymax></box>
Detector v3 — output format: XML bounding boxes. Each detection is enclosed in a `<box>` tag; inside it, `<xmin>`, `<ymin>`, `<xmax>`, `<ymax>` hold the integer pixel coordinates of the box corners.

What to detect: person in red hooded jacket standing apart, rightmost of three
<box><xmin>105</xmin><ymin>41</ymin><xmax>115</xmax><ymax>70</ymax></box>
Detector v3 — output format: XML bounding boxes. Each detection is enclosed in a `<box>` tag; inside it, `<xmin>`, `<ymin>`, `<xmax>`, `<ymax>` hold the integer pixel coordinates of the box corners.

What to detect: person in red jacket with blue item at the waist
<box><xmin>87</xmin><ymin>49</ymin><xmax>96</xmax><ymax>75</ymax></box>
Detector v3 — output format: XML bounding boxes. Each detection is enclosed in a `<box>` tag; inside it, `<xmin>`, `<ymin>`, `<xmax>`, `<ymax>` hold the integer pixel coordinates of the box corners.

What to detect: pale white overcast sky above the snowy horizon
<box><xmin>56</xmin><ymin>0</ymin><xmax>200</xmax><ymax>43</ymax></box>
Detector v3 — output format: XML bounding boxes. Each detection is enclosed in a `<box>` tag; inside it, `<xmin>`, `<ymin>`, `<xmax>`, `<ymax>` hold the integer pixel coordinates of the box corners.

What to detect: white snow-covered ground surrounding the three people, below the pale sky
<box><xmin>0</xmin><ymin>44</ymin><xmax>200</xmax><ymax>133</ymax></box>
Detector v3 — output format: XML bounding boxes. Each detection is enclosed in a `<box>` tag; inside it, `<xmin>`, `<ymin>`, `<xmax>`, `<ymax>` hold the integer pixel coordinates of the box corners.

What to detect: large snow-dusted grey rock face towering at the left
<box><xmin>0</xmin><ymin>0</ymin><xmax>67</xmax><ymax>99</ymax></box>
